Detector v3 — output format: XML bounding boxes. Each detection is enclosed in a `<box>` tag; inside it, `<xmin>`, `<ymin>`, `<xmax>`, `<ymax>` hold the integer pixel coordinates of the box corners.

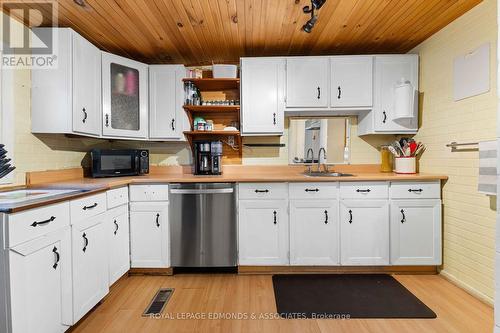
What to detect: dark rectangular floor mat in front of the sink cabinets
<box><xmin>273</xmin><ymin>274</ymin><xmax>437</xmax><ymax>318</ymax></box>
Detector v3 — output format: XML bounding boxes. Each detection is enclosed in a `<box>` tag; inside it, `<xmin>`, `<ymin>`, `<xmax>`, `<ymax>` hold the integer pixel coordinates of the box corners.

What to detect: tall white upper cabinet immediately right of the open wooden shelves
<box><xmin>241</xmin><ymin>58</ymin><xmax>285</xmax><ymax>136</ymax></box>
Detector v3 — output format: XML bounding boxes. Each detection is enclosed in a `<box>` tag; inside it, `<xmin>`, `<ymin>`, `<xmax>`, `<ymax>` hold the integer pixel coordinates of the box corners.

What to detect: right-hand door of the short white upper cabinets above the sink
<box><xmin>330</xmin><ymin>56</ymin><xmax>373</xmax><ymax>109</ymax></box>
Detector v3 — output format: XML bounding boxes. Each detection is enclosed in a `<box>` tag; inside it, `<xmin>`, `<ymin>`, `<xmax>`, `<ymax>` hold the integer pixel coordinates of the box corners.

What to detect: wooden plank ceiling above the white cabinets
<box><xmin>8</xmin><ymin>0</ymin><xmax>481</xmax><ymax>65</ymax></box>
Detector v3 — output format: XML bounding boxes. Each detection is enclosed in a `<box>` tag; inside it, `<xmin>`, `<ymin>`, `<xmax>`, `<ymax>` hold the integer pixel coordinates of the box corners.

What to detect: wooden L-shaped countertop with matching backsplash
<box><xmin>0</xmin><ymin>164</ymin><xmax>448</xmax><ymax>213</ymax></box>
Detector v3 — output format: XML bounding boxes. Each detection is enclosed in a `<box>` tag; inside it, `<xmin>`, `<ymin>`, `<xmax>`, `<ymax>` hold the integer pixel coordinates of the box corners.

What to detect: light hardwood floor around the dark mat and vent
<box><xmin>72</xmin><ymin>274</ymin><xmax>493</xmax><ymax>333</ymax></box>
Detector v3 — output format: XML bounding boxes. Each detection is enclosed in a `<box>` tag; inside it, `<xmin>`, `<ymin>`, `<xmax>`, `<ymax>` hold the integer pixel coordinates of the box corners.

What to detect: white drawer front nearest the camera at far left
<box><xmin>7</xmin><ymin>201</ymin><xmax>70</xmax><ymax>247</ymax></box>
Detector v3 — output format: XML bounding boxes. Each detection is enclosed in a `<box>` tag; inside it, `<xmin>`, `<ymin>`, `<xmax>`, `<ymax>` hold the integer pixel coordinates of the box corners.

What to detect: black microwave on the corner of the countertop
<box><xmin>90</xmin><ymin>149</ymin><xmax>149</xmax><ymax>178</ymax></box>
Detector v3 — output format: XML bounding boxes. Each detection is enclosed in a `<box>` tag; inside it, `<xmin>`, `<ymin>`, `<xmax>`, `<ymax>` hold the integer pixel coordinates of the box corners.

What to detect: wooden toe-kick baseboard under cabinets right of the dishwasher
<box><xmin>238</xmin><ymin>266</ymin><xmax>437</xmax><ymax>274</ymax></box>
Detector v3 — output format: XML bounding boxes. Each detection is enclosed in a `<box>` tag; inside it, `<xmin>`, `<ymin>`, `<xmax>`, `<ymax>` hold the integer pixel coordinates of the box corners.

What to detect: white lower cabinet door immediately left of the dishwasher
<box><xmin>130</xmin><ymin>202</ymin><xmax>170</xmax><ymax>268</ymax></box>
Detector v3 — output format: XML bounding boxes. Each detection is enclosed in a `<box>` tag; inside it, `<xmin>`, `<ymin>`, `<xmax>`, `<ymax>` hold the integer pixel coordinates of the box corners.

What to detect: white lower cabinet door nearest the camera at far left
<box><xmin>7</xmin><ymin>227</ymin><xmax>73</xmax><ymax>333</ymax></box>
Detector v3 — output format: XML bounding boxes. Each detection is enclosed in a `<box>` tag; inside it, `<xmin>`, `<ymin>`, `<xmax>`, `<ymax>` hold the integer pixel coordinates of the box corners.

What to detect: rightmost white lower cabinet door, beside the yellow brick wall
<box><xmin>390</xmin><ymin>199</ymin><xmax>441</xmax><ymax>265</ymax></box>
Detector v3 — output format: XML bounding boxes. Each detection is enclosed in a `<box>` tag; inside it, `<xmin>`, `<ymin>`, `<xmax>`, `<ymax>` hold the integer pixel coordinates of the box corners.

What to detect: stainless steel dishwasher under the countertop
<box><xmin>169</xmin><ymin>183</ymin><xmax>237</xmax><ymax>267</ymax></box>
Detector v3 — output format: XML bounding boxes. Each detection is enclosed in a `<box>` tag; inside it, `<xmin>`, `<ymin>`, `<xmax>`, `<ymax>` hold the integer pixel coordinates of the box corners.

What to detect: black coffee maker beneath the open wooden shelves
<box><xmin>194</xmin><ymin>141</ymin><xmax>222</xmax><ymax>175</ymax></box>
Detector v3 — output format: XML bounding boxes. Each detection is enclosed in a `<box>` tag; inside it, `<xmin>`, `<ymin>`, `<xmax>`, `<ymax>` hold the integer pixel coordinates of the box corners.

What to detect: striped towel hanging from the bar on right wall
<box><xmin>478</xmin><ymin>140</ymin><xmax>497</xmax><ymax>195</ymax></box>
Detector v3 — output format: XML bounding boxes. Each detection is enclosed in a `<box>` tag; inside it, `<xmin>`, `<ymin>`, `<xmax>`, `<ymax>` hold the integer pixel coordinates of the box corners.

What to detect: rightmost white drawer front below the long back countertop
<box><xmin>390</xmin><ymin>182</ymin><xmax>441</xmax><ymax>199</ymax></box>
